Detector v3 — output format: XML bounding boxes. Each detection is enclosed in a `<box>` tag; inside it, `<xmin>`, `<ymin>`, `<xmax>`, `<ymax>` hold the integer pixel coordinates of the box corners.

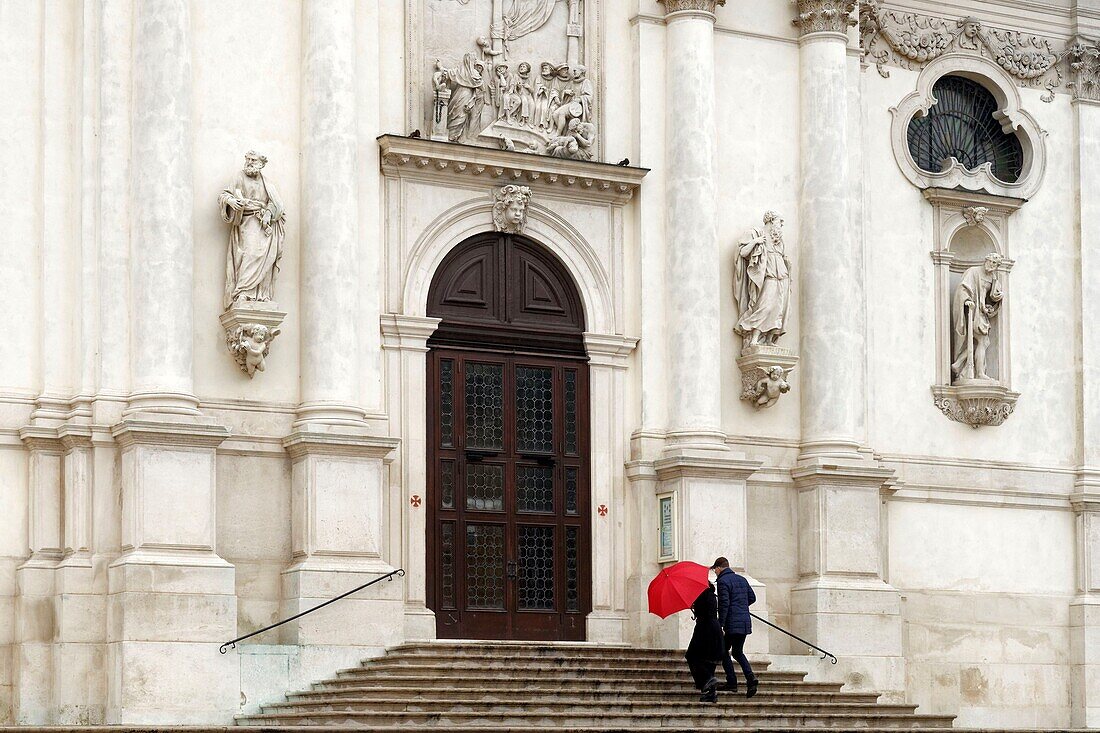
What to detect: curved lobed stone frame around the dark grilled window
<box><xmin>890</xmin><ymin>53</ymin><xmax>1046</xmax><ymax>200</ymax></box>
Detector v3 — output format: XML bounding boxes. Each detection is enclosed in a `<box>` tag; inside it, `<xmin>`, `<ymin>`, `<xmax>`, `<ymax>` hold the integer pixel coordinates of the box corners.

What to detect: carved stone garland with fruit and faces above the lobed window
<box><xmin>858</xmin><ymin>0</ymin><xmax>1100</xmax><ymax>102</ymax></box>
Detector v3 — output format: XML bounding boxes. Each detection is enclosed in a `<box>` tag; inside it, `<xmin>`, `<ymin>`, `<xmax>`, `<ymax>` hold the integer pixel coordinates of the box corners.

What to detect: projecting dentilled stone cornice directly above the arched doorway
<box><xmin>378</xmin><ymin>135</ymin><xmax>649</xmax><ymax>204</ymax></box>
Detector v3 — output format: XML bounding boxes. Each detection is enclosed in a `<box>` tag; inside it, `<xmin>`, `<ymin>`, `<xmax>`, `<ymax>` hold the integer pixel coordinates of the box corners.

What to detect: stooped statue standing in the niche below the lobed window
<box><xmin>952</xmin><ymin>252</ymin><xmax>1004</xmax><ymax>384</ymax></box>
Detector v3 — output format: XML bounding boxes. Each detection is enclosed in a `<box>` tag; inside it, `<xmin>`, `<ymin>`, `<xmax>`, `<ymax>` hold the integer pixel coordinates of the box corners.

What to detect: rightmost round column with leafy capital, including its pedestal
<box><xmin>791</xmin><ymin>0</ymin><xmax>905</xmax><ymax>700</ymax></box>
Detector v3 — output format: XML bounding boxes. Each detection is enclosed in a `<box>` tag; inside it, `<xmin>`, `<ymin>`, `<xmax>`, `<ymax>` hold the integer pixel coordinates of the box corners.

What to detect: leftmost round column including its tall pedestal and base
<box><xmin>106</xmin><ymin>0</ymin><xmax>239</xmax><ymax>724</ymax></box>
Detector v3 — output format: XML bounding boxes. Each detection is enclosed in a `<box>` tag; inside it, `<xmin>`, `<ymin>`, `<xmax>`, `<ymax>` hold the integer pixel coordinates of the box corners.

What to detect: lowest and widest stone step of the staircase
<box><xmin>238</xmin><ymin>703</ymin><xmax>954</xmax><ymax>730</ymax></box>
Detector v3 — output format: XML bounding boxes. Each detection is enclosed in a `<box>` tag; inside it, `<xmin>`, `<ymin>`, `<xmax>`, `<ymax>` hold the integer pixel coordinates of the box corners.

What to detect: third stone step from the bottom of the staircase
<box><xmin>287</xmin><ymin>680</ymin><xmax>879</xmax><ymax>704</ymax></box>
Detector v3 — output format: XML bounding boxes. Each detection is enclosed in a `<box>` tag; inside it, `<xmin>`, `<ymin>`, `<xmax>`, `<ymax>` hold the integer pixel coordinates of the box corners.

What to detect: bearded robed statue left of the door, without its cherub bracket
<box><xmin>218</xmin><ymin>151</ymin><xmax>286</xmax><ymax>309</ymax></box>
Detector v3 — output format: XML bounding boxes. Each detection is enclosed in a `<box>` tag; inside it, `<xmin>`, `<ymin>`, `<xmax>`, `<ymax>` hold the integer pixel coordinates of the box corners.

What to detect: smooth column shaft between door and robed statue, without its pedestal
<box><xmin>663</xmin><ymin>0</ymin><xmax>725</xmax><ymax>441</ymax></box>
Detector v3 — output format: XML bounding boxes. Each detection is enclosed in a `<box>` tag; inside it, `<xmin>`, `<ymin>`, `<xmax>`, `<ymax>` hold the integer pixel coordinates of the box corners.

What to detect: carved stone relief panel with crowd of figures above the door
<box><xmin>430</xmin><ymin>0</ymin><xmax>596</xmax><ymax>161</ymax></box>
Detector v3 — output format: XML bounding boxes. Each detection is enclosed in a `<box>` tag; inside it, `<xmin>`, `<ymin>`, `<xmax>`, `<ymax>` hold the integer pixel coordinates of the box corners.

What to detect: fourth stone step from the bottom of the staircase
<box><xmin>310</xmin><ymin>669</ymin><xmax>843</xmax><ymax>694</ymax></box>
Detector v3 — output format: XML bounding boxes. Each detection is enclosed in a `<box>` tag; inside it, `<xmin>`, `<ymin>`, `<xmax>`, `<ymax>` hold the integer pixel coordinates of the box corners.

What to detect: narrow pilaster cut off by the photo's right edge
<box><xmin>1067</xmin><ymin>55</ymin><xmax>1100</xmax><ymax>727</ymax></box>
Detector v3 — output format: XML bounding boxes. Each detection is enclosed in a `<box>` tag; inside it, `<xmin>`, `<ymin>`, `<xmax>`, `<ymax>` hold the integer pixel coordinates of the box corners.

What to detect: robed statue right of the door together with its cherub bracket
<box><xmin>734</xmin><ymin>211</ymin><xmax>799</xmax><ymax>408</ymax></box>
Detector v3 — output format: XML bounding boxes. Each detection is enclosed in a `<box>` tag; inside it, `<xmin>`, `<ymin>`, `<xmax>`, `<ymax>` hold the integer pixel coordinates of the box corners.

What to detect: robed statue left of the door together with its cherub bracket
<box><xmin>218</xmin><ymin>151</ymin><xmax>286</xmax><ymax>378</ymax></box>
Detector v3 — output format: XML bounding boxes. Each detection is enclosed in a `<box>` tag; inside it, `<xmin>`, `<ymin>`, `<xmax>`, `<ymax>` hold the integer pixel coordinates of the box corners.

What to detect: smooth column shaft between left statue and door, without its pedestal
<box><xmin>298</xmin><ymin>0</ymin><xmax>365</xmax><ymax>424</ymax></box>
